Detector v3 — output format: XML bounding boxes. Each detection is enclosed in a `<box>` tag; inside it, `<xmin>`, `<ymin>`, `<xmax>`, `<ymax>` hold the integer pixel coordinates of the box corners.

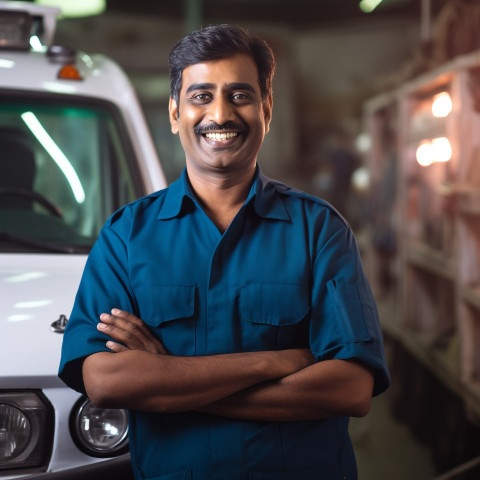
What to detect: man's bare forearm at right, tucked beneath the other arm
<box><xmin>200</xmin><ymin>360</ymin><xmax>373</xmax><ymax>421</ymax></box>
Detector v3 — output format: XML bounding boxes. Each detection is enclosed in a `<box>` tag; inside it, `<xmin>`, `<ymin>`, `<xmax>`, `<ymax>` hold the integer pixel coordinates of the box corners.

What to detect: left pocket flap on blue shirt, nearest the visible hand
<box><xmin>135</xmin><ymin>285</ymin><xmax>195</xmax><ymax>327</ymax></box>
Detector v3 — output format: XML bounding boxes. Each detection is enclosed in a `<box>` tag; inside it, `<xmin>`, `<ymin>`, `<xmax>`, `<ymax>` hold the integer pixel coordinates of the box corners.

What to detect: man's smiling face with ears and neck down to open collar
<box><xmin>169</xmin><ymin>53</ymin><xmax>272</xmax><ymax>233</ymax></box>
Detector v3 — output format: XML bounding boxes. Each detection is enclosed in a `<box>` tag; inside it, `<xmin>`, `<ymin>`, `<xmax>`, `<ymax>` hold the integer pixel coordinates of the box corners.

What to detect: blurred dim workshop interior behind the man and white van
<box><xmin>3</xmin><ymin>0</ymin><xmax>480</xmax><ymax>480</ymax></box>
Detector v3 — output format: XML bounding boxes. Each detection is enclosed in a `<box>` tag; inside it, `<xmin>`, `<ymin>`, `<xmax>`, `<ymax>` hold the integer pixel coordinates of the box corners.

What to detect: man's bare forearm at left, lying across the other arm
<box><xmin>83</xmin><ymin>349</ymin><xmax>313</xmax><ymax>412</ymax></box>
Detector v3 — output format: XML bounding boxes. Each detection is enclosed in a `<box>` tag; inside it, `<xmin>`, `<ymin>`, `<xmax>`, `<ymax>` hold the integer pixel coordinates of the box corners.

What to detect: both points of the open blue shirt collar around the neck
<box><xmin>157</xmin><ymin>165</ymin><xmax>290</xmax><ymax>220</ymax></box>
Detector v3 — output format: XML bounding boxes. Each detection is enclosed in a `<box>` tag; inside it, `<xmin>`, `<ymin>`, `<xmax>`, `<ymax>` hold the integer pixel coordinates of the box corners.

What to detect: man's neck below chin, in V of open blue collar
<box><xmin>187</xmin><ymin>166</ymin><xmax>255</xmax><ymax>233</ymax></box>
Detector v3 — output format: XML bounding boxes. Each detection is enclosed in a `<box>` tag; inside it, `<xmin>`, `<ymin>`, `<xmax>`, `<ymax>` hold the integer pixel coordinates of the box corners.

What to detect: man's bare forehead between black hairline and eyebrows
<box><xmin>181</xmin><ymin>54</ymin><xmax>260</xmax><ymax>93</ymax></box>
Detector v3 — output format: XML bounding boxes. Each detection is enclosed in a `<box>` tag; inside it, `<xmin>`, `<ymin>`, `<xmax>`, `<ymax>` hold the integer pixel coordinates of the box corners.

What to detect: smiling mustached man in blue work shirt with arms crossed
<box><xmin>60</xmin><ymin>25</ymin><xmax>389</xmax><ymax>480</ymax></box>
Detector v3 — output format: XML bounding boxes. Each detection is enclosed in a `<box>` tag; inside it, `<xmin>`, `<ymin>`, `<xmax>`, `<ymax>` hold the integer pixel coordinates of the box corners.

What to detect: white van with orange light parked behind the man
<box><xmin>0</xmin><ymin>1</ymin><xmax>166</xmax><ymax>480</ymax></box>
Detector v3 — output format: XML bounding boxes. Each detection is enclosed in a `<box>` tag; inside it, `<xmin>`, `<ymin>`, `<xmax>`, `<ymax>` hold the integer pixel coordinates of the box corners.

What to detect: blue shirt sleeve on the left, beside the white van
<box><xmin>59</xmin><ymin>213</ymin><xmax>137</xmax><ymax>393</ymax></box>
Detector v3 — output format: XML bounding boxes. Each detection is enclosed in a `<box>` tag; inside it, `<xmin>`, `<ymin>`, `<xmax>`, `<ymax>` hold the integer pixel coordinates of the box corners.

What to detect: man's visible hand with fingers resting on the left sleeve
<box><xmin>97</xmin><ymin>308</ymin><xmax>168</xmax><ymax>355</ymax></box>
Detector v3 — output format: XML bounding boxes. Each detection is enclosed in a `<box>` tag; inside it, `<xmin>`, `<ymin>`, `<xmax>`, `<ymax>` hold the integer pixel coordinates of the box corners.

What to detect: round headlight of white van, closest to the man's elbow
<box><xmin>70</xmin><ymin>398</ymin><xmax>128</xmax><ymax>457</ymax></box>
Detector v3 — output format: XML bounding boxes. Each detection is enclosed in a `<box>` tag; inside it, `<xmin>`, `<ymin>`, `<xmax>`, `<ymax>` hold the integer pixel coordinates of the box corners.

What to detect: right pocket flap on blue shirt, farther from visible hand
<box><xmin>240</xmin><ymin>283</ymin><xmax>310</xmax><ymax>326</ymax></box>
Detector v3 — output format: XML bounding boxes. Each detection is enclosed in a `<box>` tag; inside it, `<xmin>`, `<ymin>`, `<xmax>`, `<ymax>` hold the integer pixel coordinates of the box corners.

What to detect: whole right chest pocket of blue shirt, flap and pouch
<box><xmin>240</xmin><ymin>283</ymin><xmax>310</xmax><ymax>351</ymax></box>
